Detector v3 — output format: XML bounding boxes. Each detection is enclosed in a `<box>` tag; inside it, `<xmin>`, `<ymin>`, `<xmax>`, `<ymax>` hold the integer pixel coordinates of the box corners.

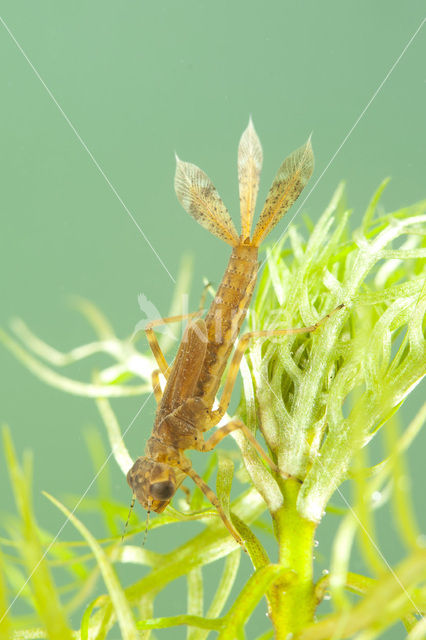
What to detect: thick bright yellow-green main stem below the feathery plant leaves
<box><xmin>267</xmin><ymin>478</ymin><xmax>316</xmax><ymax>640</ymax></box>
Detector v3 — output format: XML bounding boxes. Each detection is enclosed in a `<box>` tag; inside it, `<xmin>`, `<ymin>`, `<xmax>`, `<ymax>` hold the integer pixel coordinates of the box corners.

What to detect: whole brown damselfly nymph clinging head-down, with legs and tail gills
<box><xmin>127</xmin><ymin>121</ymin><xmax>319</xmax><ymax>544</ymax></box>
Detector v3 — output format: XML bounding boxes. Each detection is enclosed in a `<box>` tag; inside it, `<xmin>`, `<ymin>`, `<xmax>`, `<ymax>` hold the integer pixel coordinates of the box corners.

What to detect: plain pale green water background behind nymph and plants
<box><xmin>0</xmin><ymin>0</ymin><xmax>426</xmax><ymax>638</ymax></box>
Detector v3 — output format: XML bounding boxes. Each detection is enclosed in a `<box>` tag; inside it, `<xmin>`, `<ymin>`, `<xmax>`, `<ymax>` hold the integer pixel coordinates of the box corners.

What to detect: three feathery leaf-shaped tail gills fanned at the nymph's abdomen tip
<box><xmin>175</xmin><ymin>119</ymin><xmax>314</xmax><ymax>247</ymax></box>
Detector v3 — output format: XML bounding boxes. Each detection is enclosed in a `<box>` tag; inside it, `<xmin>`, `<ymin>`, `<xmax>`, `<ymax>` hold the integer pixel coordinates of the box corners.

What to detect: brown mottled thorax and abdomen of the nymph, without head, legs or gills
<box><xmin>141</xmin><ymin>246</ymin><xmax>258</xmax><ymax>480</ymax></box>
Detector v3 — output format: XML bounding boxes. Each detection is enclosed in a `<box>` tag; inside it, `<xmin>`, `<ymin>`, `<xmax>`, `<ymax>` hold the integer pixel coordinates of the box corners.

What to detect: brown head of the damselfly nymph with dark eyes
<box><xmin>127</xmin><ymin>457</ymin><xmax>177</xmax><ymax>513</ymax></box>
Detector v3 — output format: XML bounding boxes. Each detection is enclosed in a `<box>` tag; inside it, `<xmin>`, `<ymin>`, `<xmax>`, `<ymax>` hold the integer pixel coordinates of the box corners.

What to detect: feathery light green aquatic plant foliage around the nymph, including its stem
<box><xmin>0</xmin><ymin>183</ymin><xmax>426</xmax><ymax>640</ymax></box>
